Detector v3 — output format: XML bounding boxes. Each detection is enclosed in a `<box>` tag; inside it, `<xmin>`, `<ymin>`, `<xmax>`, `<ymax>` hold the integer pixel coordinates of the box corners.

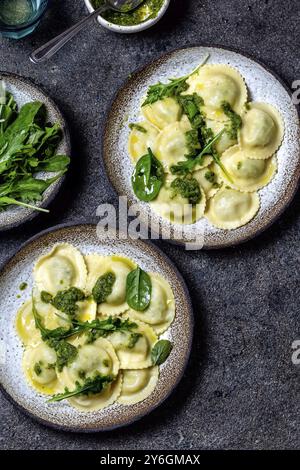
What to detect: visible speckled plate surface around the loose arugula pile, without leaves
<box><xmin>0</xmin><ymin>72</ymin><xmax>71</xmax><ymax>231</ymax></box>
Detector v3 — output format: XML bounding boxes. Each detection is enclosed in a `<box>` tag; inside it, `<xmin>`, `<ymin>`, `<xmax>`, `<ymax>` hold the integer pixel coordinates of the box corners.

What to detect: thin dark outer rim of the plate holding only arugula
<box><xmin>0</xmin><ymin>70</ymin><xmax>72</xmax><ymax>233</ymax></box>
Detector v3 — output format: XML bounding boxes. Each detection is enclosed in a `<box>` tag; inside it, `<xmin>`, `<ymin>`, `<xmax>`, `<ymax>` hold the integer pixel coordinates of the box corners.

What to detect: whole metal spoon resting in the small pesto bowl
<box><xmin>30</xmin><ymin>0</ymin><xmax>144</xmax><ymax>64</ymax></box>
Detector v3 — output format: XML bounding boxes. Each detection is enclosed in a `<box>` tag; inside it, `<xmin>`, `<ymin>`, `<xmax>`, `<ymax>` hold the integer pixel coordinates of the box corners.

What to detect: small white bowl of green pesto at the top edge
<box><xmin>84</xmin><ymin>0</ymin><xmax>170</xmax><ymax>34</ymax></box>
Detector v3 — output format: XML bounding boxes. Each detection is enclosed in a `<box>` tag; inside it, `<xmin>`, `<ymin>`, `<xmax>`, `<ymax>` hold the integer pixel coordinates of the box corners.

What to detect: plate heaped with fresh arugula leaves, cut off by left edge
<box><xmin>0</xmin><ymin>73</ymin><xmax>70</xmax><ymax>230</ymax></box>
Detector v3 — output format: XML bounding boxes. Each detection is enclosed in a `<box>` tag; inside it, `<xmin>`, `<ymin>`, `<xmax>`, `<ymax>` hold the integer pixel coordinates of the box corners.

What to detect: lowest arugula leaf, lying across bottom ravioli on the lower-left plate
<box><xmin>48</xmin><ymin>374</ymin><xmax>115</xmax><ymax>403</ymax></box>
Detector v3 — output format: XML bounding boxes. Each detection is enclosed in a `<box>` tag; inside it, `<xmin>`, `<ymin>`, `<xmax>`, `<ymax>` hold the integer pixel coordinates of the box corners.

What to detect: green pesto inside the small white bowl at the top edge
<box><xmin>92</xmin><ymin>0</ymin><xmax>164</xmax><ymax>26</ymax></box>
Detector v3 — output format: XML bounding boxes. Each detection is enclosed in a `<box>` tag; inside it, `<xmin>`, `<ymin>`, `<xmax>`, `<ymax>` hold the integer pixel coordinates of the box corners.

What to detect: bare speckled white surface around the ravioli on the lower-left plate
<box><xmin>0</xmin><ymin>224</ymin><xmax>193</xmax><ymax>432</ymax></box>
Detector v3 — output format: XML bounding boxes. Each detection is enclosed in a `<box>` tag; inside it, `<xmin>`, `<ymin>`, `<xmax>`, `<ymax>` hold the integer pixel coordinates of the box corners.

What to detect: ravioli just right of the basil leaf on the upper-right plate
<box><xmin>153</xmin><ymin>120</ymin><xmax>191</xmax><ymax>172</ymax></box>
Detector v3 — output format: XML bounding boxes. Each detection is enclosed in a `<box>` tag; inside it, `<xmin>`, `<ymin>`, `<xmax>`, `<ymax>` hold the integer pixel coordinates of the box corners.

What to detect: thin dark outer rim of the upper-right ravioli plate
<box><xmin>101</xmin><ymin>42</ymin><xmax>300</xmax><ymax>252</ymax></box>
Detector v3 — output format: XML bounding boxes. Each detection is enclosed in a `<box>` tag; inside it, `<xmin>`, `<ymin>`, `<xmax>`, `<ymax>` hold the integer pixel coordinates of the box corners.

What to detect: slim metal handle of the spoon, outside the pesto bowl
<box><xmin>30</xmin><ymin>6</ymin><xmax>109</xmax><ymax>64</ymax></box>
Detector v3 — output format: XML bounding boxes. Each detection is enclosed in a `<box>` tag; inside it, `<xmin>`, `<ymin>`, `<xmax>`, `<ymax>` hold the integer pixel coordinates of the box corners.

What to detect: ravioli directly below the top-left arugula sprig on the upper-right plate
<box><xmin>142</xmin><ymin>98</ymin><xmax>182</xmax><ymax>129</ymax></box>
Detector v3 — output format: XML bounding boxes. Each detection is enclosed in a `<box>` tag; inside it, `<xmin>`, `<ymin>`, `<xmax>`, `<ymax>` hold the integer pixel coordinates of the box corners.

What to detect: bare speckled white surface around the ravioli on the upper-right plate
<box><xmin>103</xmin><ymin>46</ymin><xmax>300</xmax><ymax>248</ymax></box>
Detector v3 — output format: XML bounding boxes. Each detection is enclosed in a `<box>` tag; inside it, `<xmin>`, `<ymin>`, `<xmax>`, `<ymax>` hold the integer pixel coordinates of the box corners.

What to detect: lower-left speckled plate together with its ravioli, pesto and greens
<box><xmin>0</xmin><ymin>225</ymin><xmax>193</xmax><ymax>431</ymax></box>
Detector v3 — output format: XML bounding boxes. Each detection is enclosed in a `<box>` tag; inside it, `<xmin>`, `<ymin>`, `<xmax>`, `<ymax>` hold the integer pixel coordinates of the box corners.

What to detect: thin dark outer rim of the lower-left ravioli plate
<box><xmin>0</xmin><ymin>219</ymin><xmax>195</xmax><ymax>434</ymax></box>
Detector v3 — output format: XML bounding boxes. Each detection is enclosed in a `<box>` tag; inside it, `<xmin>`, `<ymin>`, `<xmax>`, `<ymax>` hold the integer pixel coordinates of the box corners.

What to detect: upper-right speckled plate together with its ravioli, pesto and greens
<box><xmin>104</xmin><ymin>47</ymin><xmax>300</xmax><ymax>249</ymax></box>
